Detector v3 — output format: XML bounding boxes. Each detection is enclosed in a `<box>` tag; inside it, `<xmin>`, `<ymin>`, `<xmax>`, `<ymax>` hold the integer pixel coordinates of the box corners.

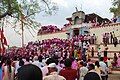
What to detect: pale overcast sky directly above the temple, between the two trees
<box><xmin>37</xmin><ymin>0</ymin><xmax>112</xmax><ymax>27</ymax></box>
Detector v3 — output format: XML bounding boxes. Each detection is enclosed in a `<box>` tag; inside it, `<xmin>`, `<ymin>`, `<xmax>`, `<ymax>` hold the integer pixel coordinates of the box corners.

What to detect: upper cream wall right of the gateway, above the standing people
<box><xmin>90</xmin><ymin>23</ymin><xmax>120</xmax><ymax>43</ymax></box>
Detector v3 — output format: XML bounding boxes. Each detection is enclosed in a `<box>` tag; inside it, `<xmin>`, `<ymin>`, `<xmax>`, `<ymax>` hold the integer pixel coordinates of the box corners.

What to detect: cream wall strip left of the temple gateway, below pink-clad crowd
<box><xmin>37</xmin><ymin>31</ymin><xmax>67</xmax><ymax>41</ymax></box>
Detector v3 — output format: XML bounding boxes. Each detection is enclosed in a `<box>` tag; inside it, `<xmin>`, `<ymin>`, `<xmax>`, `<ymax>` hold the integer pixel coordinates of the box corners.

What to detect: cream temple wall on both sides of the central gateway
<box><xmin>37</xmin><ymin>23</ymin><xmax>120</xmax><ymax>53</ymax></box>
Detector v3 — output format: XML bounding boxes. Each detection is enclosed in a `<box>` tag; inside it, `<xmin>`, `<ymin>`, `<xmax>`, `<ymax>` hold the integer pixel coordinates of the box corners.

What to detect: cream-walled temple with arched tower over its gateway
<box><xmin>37</xmin><ymin>11</ymin><xmax>120</xmax><ymax>57</ymax></box>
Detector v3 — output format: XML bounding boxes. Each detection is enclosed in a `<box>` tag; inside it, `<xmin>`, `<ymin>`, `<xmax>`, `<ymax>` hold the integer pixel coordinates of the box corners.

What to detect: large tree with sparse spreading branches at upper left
<box><xmin>0</xmin><ymin>0</ymin><xmax>58</xmax><ymax>46</ymax></box>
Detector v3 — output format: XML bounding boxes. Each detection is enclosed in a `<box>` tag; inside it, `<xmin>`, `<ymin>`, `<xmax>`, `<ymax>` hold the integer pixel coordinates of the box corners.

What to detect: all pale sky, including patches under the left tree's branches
<box><xmin>5</xmin><ymin>0</ymin><xmax>113</xmax><ymax>46</ymax></box>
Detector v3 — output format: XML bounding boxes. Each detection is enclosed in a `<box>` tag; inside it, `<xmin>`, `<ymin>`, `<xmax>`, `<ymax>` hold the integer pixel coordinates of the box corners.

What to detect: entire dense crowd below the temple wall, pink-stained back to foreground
<box><xmin>0</xmin><ymin>34</ymin><xmax>120</xmax><ymax>80</ymax></box>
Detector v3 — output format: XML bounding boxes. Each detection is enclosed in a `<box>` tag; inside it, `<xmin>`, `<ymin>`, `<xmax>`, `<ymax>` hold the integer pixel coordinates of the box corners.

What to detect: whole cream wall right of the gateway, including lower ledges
<box><xmin>89</xmin><ymin>23</ymin><xmax>120</xmax><ymax>58</ymax></box>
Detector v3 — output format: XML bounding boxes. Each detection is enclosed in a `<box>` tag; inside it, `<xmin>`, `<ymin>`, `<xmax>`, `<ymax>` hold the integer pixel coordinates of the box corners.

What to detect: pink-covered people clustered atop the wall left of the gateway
<box><xmin>38</xmin><ymin>25</ymin><xmax>60</xmax><ymax>35</ymax></box>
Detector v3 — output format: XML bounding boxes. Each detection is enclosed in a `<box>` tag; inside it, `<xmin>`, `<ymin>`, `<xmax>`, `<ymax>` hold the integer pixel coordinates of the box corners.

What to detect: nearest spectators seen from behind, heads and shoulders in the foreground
<box><xmin>0</xmin><ymin>55</ymin><xmax>108</xmax><ymax>80</ymax></box>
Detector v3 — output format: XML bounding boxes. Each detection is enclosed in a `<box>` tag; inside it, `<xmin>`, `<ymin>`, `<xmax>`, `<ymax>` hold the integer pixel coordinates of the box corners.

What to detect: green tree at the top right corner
<box><xmin>110</xmin><ymin>0</ymin><xmax>120</xmax><ymax>17</ymax></box>
